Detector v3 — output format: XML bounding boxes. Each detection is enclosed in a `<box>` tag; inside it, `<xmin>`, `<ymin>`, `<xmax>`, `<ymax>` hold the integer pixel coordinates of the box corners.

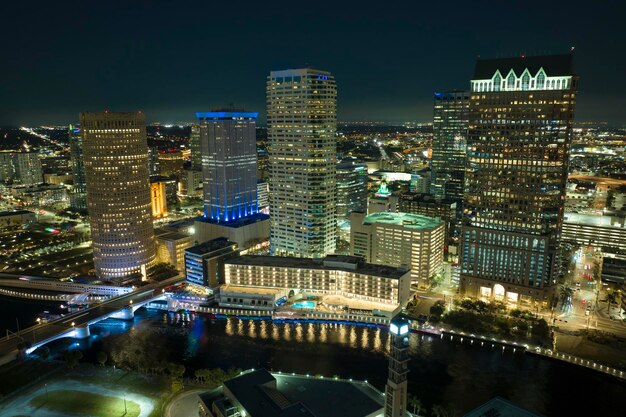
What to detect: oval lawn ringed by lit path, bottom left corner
<box><xmin>30</xmin><ymin>390</ymin><xmax>140</xmax><ymax>417</ymax></box>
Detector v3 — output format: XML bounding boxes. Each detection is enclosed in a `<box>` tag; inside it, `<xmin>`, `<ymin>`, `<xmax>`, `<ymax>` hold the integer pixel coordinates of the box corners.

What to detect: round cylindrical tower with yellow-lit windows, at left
<box><xmin>80</xmin><ymin>112</ymin><xmax>155</xmax><ymax>278</ymax></box>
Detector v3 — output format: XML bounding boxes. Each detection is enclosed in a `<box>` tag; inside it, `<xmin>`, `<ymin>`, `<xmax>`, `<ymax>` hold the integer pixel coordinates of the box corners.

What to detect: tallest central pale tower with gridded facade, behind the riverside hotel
<box><xmin>267</xmin><ymin>68</ymin><xmax>337</xmax><ymax>257</ymax></box>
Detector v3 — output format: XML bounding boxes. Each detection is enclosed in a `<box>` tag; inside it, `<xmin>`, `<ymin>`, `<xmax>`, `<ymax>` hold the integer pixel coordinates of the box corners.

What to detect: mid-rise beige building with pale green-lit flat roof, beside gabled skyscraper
<box><xmin>350</xmin><ymin>212</ymin><xmax>444</xmax><ymax>288</ymax></box>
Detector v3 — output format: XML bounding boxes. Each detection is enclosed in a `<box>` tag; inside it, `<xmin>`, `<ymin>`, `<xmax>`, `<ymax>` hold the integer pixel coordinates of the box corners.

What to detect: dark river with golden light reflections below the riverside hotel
<box><xmin>0</xmin><ymin>299</ymin><xmax>626</xmax><ymax>417</ymax></box>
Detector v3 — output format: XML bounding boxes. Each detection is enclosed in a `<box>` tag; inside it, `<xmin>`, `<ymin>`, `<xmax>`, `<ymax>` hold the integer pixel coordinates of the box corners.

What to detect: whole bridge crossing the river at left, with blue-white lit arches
<box><xmin>0</xmin><ymin>275</ymin><xmax>184</xmax><ymax>365</ymax></box>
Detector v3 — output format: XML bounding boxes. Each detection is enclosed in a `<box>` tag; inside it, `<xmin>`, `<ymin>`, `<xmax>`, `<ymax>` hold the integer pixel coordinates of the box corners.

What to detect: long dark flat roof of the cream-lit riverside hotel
<box><xmin>226</xmin><ymin>255</ymin><xmax>407</xmax><ymax>279</ymax></box>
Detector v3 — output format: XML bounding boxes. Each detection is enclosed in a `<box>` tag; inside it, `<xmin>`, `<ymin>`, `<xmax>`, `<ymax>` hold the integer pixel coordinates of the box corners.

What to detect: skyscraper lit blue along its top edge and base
<box><xmin>196</xmin><ymin>111</ymin><xmax>258</xmax><ymax>223</ymax></box>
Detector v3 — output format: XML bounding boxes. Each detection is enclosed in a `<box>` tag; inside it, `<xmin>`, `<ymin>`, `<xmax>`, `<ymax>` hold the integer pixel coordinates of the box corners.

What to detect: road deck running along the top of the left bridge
<box><xmin>0</xmin><ymin>275</ymin><xmax>183</xmax><ymax>358</ymax></box>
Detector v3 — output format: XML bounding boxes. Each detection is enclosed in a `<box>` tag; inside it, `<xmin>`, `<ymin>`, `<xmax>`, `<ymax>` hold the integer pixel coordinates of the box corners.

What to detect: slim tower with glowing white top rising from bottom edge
<box><xmin>385</xmin><ymin>314</ymin><xmax>409</xmax><ymax>417</ymax></box>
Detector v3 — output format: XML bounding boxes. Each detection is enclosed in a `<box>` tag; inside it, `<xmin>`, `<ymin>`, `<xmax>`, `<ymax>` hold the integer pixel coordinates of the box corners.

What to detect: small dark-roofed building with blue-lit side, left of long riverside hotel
<box><xmin>185</xmin><ymin>237</ymin><xmax>239</xmax><ymax>288</ymax></box>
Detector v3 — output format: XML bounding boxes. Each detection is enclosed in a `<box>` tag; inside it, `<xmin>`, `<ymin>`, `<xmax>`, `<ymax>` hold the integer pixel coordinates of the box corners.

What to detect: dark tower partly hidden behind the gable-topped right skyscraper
<box><xmin>430</xmin><ymin>91</ymin><xmax>470</xmax><ymax>202</ymax></box>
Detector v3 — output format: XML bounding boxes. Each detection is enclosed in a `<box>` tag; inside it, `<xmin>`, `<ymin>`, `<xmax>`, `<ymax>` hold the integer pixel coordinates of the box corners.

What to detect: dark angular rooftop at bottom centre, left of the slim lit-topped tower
<box><xmin>212</xmin><ymin>369</ymin><xmax>384</xmax><ymax>417</ymax></box>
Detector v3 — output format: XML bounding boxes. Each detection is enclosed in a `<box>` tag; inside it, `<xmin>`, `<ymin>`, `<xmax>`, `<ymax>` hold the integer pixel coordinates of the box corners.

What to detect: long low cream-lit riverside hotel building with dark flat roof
<box><xmin>225</xmin><ymin>255</ymin><xmax>410</xmax><ymax>306</ymax></box>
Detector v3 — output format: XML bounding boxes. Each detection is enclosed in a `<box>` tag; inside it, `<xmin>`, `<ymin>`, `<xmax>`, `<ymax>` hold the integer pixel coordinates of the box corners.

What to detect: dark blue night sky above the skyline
<box><xmin>0</xmin><ymin>0</ymin><xmax>626</xmax><ymax>126</ymax></box>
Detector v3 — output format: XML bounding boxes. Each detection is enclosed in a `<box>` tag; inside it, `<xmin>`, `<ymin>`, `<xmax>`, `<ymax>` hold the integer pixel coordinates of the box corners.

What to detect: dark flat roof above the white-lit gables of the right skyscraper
<box><xmin>473</xmin><ymin>54</ymin><xmax>574</xmax><ymax>80</ymax></box>
